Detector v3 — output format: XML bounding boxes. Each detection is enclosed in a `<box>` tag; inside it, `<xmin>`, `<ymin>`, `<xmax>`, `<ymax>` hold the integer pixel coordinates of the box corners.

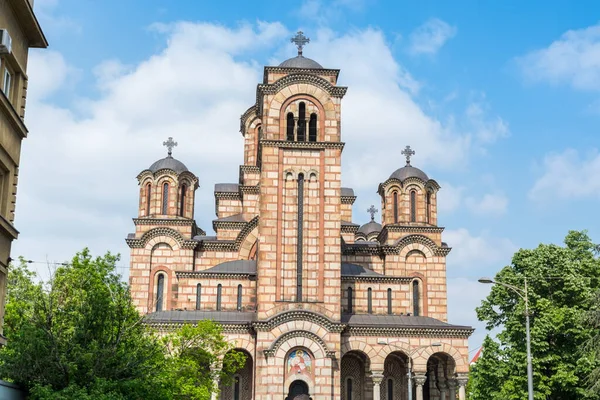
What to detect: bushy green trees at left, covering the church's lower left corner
<box><xmin>0</xmin><ymin>249</ymin><xmax>245</xmax><ymax>400</ymax></box>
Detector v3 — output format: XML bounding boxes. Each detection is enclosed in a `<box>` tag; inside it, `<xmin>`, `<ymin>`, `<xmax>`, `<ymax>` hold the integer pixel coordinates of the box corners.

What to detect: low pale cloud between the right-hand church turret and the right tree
<box><xmin>444</xmin><ymin>228</ymin><xmax>518</xmax><ymax>271</ymax></box>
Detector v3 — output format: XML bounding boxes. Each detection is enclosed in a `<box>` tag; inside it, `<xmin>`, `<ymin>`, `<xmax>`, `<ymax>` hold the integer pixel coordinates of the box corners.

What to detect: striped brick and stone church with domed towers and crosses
<box><xmin>126</xmin><ymin>32</ymin><xmax>473</xmax><ymax>400</ymax></box>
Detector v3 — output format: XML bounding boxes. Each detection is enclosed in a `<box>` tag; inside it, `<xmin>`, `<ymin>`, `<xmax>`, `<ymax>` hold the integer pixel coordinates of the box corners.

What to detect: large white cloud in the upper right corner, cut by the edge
<box><xmin>517</xmin><ymin>24</ymin><xmax>600</xmax><ymax>91</ymax></box>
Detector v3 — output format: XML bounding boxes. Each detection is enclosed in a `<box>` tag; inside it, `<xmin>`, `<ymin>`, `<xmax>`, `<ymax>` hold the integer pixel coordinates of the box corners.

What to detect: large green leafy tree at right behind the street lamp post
<box><xmin>470</xmin><ymin>231</ymin><xmax>600</xmax><ymax>400</ymax></box>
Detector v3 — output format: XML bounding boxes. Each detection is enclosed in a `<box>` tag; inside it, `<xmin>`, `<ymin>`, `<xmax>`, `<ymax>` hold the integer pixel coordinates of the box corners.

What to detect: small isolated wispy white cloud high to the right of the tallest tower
<box><xmin>408</xmin><ymin>18</ymin><xmax>456</xmax><ymax>55</ymax></box>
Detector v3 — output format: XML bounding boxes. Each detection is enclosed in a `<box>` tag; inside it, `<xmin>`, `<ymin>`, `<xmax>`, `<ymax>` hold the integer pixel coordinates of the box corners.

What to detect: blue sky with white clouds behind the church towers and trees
<box><xmin>12</xmin><ymin>0</ymin><xmax>600</xmax><ymax>355</ymax></box>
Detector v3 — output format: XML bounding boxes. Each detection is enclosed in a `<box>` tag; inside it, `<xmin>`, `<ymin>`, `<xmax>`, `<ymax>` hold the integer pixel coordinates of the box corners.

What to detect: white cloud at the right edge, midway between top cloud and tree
<box><xmin>529</xmin><ymin>149</ymin><xmax>600</xmax><ymax>202</ymax></box>
